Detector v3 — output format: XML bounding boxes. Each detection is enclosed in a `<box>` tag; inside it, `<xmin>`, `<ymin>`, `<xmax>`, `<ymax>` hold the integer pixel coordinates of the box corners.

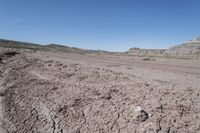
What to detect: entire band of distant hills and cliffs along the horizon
<box><xmin>0</xmin><ymin>36</ymin><xmax>200</xmax><ymax>57</ymax></box>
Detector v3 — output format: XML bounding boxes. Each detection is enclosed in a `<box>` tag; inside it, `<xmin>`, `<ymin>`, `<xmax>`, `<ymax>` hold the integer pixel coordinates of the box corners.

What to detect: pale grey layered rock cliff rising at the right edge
<box><xmin>165</xmin><ymin>36</ymin><xmax>200</xmax><ymax>55</ymax></box>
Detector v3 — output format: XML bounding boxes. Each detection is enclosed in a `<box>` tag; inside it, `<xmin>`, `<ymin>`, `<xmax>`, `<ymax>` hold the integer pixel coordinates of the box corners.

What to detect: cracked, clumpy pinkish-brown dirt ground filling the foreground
<box><xmin>0</xmin><ymin>49</ymin><xmax>200</xmax><ymax>133</ymax></box>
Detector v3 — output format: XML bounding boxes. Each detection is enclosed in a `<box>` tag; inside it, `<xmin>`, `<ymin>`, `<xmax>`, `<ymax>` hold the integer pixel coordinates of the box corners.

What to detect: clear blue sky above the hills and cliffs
<box><xmin>0</xmin><ymin>0</ymin><xmax>200</xmax><ymax>51</ymax></box>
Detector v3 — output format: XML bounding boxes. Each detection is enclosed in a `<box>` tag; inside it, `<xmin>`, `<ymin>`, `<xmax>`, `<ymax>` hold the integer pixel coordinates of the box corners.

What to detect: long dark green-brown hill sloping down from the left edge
<box><xmin>0</xmin><ymin>39</ymin><xmax>112</xmax><ymax>54</ymax></box>
